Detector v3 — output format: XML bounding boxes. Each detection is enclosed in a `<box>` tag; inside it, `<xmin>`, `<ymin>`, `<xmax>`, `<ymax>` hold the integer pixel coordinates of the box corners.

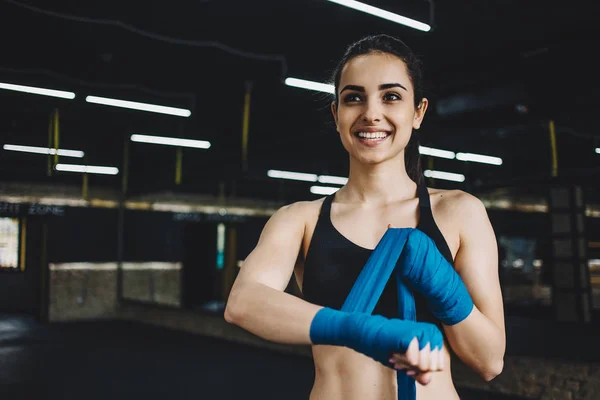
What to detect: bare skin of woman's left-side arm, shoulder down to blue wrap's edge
<box><xmin>225</xmin><ymin>203</ymin><xmax>322</xmax><ymax>344</ymax></box>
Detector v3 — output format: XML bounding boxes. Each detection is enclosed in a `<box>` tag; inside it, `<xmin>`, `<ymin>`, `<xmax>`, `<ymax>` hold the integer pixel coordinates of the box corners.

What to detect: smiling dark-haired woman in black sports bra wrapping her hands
<box><xmin>225</xmin><ymin>35</ymin><xmax>505</xmax><ymax>400</ymax></box>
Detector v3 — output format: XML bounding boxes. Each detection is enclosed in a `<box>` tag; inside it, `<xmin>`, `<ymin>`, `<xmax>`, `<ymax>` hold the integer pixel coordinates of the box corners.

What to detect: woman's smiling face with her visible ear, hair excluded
<box><xmin>332</xmin><ymin>53</ymin><xmax>428</xmax><ymax>164</ymax></box>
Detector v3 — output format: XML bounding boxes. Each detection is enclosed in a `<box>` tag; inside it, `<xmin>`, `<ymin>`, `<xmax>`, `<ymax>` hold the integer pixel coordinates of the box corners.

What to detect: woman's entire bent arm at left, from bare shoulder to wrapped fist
<box><xmin>225</xmin><ymin>203</ymin><xmax>442</xmax><ymax>385</ymax></box>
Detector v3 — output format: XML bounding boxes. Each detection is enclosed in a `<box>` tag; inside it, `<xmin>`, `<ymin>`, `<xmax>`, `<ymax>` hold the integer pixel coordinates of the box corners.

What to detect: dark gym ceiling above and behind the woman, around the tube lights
<box><xmin>0</xmin><ymin>0</ymin><xmax>600</xmax><ymax>201</ymax></box>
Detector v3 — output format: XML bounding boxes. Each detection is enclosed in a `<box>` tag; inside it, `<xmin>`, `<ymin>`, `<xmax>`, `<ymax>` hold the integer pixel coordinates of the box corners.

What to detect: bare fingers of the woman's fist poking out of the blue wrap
<box><xmin>389</xmin><ymin>338</ymin><xmax>444</xmax><ymax>385</ymax></box>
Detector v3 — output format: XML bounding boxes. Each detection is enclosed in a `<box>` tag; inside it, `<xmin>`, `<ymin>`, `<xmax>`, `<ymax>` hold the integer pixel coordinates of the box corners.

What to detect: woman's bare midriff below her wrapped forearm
<box><xmin>310</xmin><ymin>346</ymin><xmax>459</xmax><ymax>400</ymax></box>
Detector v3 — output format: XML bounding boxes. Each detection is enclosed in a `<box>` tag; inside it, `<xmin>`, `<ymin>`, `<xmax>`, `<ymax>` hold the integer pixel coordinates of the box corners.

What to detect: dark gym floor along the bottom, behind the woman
<box><xmin>0</xmin><ymin>314</ymin><xmax>528</xmax><ymax>400</ymax></box>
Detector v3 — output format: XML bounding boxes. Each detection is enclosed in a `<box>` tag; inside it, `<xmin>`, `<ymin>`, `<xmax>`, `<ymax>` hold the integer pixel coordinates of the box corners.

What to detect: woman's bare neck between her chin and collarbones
<box><xmin>337</xmin><ymin>157</ymin><xmax>416</xmax><ymax>204</ymax></box>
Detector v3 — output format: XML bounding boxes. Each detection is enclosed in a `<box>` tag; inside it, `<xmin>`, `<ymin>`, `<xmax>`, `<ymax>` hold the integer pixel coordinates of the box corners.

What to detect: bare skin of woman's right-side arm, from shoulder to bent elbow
<box><xmin>444</xmin><ymin>193</ymin><xmax>506</xmax><ymax>381</ymax></box>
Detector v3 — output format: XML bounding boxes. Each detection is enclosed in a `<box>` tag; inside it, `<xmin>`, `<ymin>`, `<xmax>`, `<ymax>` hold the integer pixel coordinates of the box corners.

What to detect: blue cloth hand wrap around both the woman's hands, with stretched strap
<box><xmin>310</xmin><ymin>228</ymin><xmax>473</xmax><ymax>399</ymax></box>
